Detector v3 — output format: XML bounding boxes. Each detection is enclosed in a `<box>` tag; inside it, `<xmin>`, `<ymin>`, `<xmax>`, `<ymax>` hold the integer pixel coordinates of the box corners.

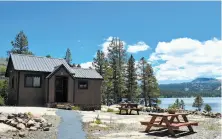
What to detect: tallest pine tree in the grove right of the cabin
<box><xmin>108</xmin><ymin>38</ymin><xmax>126</xmax><ymax>103</ymax></box>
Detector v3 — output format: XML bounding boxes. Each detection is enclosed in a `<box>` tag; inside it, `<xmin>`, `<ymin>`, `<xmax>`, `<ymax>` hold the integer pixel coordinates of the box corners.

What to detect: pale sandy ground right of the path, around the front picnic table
<box><xmin>79</xmin><ymin>111</ymin><xmax>222</xmax><ymax>139</ymax></box>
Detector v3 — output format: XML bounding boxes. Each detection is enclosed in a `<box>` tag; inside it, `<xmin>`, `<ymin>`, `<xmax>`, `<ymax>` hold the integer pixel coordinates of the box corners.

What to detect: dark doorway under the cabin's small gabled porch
<box><xmin>55</xmin><ymin>76</ymin><xmax>68</xmax><ymax>102</ymax></box>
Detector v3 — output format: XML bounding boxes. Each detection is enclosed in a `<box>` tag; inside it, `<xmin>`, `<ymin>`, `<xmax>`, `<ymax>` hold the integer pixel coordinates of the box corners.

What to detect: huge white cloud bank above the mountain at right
<box><xmin>149</xmin><ymin>38</ymin><xmax>222</xmax><ymax>81</ymax></box>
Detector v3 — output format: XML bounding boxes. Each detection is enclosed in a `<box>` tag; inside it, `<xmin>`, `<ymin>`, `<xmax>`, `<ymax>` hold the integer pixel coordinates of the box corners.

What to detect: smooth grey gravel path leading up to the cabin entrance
<box><xmin>56</xmin><ymin>110</ymin><xmax>86</xmax><ymax>139</ymax></box>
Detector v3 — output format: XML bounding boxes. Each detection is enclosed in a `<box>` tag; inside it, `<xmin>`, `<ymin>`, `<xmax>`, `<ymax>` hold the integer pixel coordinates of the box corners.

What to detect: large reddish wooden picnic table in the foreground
<box><xmin>140</xmin><ymin>113</ymin><xmax>198</xmax><ymax>136</ymax></box>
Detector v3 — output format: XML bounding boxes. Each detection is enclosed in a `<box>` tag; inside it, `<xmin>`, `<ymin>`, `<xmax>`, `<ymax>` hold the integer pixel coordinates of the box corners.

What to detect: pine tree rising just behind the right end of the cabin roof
<box><xmin>92</xmin><ymin>50</ymin><xmax>105</xmax><ymax>76</ymax></box>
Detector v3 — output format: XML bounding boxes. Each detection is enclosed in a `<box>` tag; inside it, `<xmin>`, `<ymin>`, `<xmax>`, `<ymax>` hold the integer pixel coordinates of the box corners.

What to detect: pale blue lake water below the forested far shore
<box><xmin>159</xmin><ymin>97</ymin><xmax>222</xmax><ymax>112</ymax></box>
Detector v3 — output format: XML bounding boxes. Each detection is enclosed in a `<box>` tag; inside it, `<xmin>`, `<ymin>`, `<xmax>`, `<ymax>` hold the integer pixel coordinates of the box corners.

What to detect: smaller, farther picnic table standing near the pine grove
<box><xmin>118</xmin><ymin>103</ymin><xmax>140</xmax><ymax>115</ymax></box>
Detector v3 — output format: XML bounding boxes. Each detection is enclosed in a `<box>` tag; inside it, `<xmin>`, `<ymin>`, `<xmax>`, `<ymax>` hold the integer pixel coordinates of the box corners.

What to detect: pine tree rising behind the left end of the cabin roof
<box><xmin>7</xmin><ymin>31</ymin><xmax>33</xmax><ymax>55</ymax></box>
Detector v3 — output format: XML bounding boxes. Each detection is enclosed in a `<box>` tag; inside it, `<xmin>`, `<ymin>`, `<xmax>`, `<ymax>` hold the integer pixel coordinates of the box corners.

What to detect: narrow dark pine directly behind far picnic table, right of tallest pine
<box><xmin>126</xmin><ymin>55</ymin><xmax>137</xmax><ymax>101</ymax></box>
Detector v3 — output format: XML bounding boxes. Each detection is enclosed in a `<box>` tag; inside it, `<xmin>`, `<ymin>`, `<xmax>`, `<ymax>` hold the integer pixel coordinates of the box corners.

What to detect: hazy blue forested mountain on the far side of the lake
<box><xmin>159</xmin><ymin>78</ymin><xmax>221</xmax><ymax>96</ymax></box>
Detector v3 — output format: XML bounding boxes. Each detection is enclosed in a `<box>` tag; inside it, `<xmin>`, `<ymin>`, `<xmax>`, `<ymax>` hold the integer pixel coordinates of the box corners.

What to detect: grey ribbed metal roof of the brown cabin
<box><xmin>11</xmin><ymin>54</ymin><xmax>103</xmax><ymax>79</ymax></box>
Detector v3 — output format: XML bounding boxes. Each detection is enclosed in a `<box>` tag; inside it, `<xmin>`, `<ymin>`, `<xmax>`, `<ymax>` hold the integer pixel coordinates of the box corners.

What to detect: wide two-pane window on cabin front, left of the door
<box><xmin>25</xmin><ymin>75</ymin><xmax>41</xmax><ymax>88</ymax></box>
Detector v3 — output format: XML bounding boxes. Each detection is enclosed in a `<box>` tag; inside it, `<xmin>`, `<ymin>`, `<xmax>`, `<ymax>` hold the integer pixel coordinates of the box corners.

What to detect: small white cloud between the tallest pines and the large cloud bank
<box><xmin>127</xmin><ymin>41</ymin><xmax>150</xmax><ymax>53</ymax></box>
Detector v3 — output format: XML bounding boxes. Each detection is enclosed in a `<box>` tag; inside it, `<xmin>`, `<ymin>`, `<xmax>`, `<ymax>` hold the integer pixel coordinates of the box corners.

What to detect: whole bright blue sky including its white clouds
<box><xmin>0</xmin><ymin>1</ymin><xmax>222</xmax><ymax>83</ymax></box>
